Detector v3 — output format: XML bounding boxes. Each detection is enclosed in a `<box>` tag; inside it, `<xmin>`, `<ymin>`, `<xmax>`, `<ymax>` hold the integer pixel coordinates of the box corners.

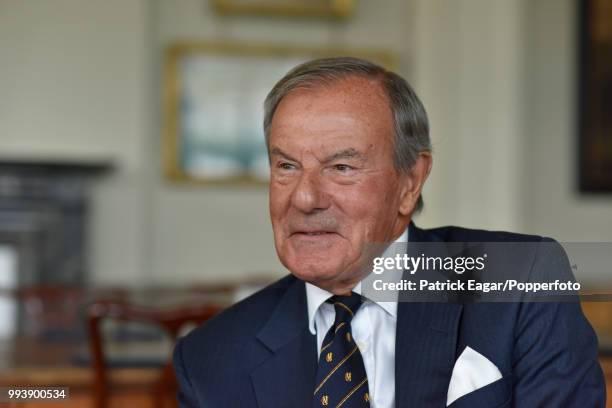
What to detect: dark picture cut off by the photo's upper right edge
<box><xmin>578</xmin><ymin>0</ymin><xmax>612</xmax><ymax>192</ymax></box>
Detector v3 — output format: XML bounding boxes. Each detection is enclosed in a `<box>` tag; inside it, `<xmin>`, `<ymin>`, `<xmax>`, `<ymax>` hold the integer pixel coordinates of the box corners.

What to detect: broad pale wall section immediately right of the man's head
<box><xmin>414</xmin><ymin>0</ymin><xmax>525</xmax><ymax>230</ymax></box>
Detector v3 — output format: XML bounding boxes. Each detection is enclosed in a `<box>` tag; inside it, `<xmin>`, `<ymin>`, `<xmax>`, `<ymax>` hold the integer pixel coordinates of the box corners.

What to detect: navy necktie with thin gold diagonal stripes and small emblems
<box><xmin>312</xmin><ymin>292</ymin><xmax>370</xmax><ymax>408</ymax></box>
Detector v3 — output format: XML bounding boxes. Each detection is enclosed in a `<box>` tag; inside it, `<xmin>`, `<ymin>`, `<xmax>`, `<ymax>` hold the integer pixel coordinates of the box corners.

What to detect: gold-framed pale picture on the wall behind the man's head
<box><xmin>163</xmin><ymin>43</ymin><xmax>396</xmax><ymax>184</ymax></box>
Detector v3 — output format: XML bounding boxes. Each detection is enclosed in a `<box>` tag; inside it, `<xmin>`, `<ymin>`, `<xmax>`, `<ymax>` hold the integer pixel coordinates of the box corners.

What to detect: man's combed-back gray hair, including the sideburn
<box><xmin>263</xmin><ymin>57</ymin><xmax>431</xmax><ymax>212</ymax></box>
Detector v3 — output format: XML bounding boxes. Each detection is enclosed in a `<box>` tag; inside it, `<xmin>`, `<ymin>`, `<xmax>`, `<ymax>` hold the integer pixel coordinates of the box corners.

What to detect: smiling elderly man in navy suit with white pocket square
<box><xmin>174</xmin><ymin>58</ymin><xmax>605</xmax><ymax>408</ymax></box>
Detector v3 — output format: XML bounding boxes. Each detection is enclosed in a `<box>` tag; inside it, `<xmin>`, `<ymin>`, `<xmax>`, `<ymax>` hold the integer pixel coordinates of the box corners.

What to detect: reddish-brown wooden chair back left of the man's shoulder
<box><xmin>87</xmin><ymin>301</ymin><xmax>222</xmax><ymax>408</ymax></box>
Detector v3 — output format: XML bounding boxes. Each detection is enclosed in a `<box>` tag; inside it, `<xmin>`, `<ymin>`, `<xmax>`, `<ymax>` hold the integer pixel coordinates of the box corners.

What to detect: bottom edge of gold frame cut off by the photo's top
<box><xmin>210</xmin><ymin>0</ymin><xmax>355</xmax><ymax>18</ymax></box>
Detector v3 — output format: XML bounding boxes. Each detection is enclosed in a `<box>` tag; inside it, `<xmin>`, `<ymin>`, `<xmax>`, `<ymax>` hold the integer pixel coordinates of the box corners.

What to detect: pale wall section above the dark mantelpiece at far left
<box><xmin>0</xmin><ymin>0</ymin><xmax>147</xmax><ymax>173</ymax></box>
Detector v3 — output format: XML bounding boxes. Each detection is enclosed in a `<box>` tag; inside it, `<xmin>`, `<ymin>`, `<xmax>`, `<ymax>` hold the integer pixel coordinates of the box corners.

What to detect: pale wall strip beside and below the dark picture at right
<box><xmin>521</xmin><ymin>0</ymin><xmax>612</xmax><ymax>242</ymax></box>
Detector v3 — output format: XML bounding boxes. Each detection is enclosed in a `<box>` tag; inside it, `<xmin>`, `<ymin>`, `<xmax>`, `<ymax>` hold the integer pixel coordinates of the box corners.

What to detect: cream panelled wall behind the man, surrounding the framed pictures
<box><xmin>0</xmin><ymin>0</ymin><xmax>612</xmax><ymax>284</ymax></box>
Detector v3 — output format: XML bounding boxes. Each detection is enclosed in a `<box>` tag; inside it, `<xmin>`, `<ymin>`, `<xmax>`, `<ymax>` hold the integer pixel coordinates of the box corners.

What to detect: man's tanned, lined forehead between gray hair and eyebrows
<box><xmin>270</xmin><ymin>76</ymin><xmax>394</xmax><ymax>149</ymax></box>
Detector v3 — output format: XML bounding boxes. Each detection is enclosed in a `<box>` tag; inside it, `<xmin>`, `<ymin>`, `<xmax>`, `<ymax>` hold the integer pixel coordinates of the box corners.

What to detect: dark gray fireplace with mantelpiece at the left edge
<box><xmin>0</xmin><ymin>159</ymin><xmax>112</xmax><ymax>337</ymax></box>
